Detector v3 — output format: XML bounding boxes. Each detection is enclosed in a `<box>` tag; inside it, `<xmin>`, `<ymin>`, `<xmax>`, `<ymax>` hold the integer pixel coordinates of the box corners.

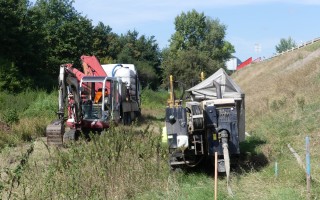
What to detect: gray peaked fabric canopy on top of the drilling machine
<box><xmin>186</xmin><ymin>68</ymin><xmax>245</xmax><ymax>142</ymax></box>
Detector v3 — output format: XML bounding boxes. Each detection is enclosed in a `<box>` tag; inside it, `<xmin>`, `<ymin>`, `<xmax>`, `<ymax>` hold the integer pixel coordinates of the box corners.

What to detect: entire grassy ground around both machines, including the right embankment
<box><xmin>0</xmin><ymin>43</ymin><xmax>320</xmax><ymax>200</ymax></box>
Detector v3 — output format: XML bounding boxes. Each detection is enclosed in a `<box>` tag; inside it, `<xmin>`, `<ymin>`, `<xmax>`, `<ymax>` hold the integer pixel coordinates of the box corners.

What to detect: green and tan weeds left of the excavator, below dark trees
<box><xmin>0</xmin><ymin>89</ymin><xmax>57</xmax><ymax>149</ymax></box>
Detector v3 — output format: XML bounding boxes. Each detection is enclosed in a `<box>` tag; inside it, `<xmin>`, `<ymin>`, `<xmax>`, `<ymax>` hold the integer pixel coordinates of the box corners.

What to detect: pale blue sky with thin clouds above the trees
<box><xmin>33</xmin><ymin>0</ymin><xmax>320</xmax><ymax>61</ymax></box>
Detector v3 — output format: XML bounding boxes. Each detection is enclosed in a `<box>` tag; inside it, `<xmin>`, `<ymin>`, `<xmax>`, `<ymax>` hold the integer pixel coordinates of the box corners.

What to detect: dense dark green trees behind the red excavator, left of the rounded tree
<box><xmin>0</xmin><ymin>0</ymin><xmax>160</xmax><ymax>92</ymax></box>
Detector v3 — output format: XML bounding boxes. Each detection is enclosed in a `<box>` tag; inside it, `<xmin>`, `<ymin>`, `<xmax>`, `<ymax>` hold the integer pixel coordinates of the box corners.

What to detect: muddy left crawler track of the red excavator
<box><xmin>46</xmin><ymin>120</ymin><xmax>64</xmax><ymax>146</ymax></box>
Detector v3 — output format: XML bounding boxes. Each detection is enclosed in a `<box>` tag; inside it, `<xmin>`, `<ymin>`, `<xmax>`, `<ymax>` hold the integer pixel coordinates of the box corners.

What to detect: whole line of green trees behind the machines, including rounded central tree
<box><xmin>0</xmin><ymin>0</ymin><xmax>234</xmax><ymax>92</ymax></box>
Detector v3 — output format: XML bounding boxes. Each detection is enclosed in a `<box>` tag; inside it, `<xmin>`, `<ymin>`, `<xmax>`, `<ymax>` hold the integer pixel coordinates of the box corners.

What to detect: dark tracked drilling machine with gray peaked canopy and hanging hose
<box><xmin>165</xmin><ymin>69</ymin><xmax>245</xmax><ymax>173</ymax></box>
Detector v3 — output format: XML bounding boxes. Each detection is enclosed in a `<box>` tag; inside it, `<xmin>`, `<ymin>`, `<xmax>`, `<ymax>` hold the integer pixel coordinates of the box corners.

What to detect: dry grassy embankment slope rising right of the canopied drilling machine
<box><xmin>233</xmin><ymin>42</ymin><xmax>320</xmax><ymax>199</ymax></box>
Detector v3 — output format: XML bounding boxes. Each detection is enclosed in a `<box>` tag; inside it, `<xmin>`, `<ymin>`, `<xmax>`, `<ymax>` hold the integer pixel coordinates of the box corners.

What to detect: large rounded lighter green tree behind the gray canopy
<box><xmin>162</xmin><ymin>10</ymin><xmax>234</xmax><ymax>86</ymax></box>
